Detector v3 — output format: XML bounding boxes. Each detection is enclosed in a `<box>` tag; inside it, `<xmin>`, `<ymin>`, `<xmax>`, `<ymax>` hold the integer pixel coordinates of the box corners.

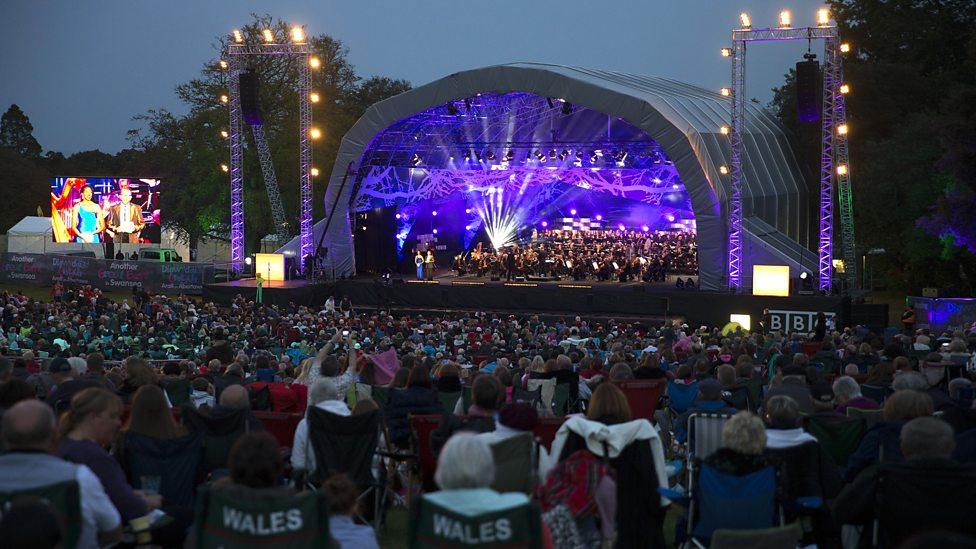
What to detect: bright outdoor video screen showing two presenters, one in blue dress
<box><xmin>51</xmin><ymin>177</ymin><xmax>160</xmax><ymax>244</ymax></box>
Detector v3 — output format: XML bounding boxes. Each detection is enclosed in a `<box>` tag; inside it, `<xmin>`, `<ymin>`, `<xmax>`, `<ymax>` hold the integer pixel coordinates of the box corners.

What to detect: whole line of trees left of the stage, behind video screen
<box><xmin>0</xmin><ymin>15</ymin><xmax>410</xmax><ymax>250</ymax></box>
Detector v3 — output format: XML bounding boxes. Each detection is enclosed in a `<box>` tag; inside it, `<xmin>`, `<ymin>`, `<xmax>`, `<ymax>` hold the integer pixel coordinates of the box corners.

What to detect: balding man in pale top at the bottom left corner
<box><xmin>0</xmin><ymin>400</ymin><xmax>122</xmax><ymax>549</ymax></box>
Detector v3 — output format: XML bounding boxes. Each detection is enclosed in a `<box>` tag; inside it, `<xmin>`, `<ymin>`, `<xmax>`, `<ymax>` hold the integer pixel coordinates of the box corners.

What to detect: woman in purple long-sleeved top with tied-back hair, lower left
<box><xmin>58</xmin><ymin>388</ymin><xmax>162</xmax><ymax>522</ymax></box>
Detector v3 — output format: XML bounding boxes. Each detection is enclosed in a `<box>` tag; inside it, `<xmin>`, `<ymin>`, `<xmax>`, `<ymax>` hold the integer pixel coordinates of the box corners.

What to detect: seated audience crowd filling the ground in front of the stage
<box><xmin>0</xmin><ymin>284</ymin><xmax>976</xmax><ymax>548</ymax></box>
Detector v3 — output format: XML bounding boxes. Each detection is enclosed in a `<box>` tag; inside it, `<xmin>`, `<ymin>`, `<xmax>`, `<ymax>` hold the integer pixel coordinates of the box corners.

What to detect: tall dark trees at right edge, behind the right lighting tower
<box><xmin>770</xmin><ymin>0</ymin><xmax>976</xmax><ymax>296</ymax></box>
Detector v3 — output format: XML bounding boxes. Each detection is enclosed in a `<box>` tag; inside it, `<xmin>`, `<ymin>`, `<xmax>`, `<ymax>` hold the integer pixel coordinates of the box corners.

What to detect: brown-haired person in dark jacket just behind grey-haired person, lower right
<box><xmin>844</xmin><ymin>390</ymin><xmax>934</xmax><ymax>482</ymax></box>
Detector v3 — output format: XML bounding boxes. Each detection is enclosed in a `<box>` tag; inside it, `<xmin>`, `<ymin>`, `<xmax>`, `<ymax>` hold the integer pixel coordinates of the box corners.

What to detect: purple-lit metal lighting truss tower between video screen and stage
<box><xmin>226</xmin><ymin>38</ymin><xmax>314</xmax><ymax>272</ymax></box>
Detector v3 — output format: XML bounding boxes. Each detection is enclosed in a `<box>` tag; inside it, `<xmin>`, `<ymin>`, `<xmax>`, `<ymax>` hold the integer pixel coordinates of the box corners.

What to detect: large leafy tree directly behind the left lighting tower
<box><xmin>130</xmin><ymin>15</ymin><xmax>410</xmax><ymax>250</ymax></box>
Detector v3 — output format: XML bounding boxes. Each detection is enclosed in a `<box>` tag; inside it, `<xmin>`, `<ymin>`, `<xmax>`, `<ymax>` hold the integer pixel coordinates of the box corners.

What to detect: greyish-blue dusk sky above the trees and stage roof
<box><xmin>0</xmin><ymin>0</ymin><xmax>823</xmax><ymax>154</ymax></box>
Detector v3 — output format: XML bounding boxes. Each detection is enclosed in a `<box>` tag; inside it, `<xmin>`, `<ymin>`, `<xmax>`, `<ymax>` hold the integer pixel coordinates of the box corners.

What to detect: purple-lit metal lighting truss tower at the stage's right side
<box><xmin>728</xmin><ymin>25</ymin><xmax>857</xmax><ymax>292</ymax></box>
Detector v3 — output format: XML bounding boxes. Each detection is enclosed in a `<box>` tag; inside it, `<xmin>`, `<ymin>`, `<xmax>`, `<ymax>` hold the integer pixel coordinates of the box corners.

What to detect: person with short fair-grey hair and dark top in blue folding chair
<box><xmin>704</xmin><ymin>412</ymin><xmax>767</xmax><ymax>476</ymax></box>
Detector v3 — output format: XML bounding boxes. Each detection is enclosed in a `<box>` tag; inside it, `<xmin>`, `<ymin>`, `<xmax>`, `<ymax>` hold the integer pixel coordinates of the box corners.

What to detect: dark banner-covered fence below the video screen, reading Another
<box><xmin>0</xmin><ymin>253</ymin><xmax>214</xmax><ymax>294</ymax></box>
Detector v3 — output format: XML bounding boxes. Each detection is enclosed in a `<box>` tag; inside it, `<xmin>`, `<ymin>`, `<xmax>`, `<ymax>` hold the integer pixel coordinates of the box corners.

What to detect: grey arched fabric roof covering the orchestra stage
<box><xmin>292</xmin><ymin>63</ymin><xmax>816</xmax><ymax>289</ymax></box>
